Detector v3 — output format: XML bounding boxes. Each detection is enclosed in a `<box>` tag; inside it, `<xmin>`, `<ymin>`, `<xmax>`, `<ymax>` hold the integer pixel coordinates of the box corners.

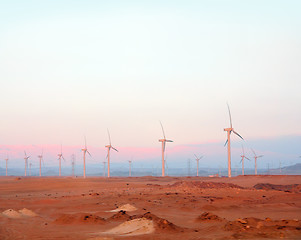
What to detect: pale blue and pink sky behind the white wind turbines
<box><xmin>0</xmin><ymin>0</ymin><xmax>301</xmax><ymax>172</ymax></box>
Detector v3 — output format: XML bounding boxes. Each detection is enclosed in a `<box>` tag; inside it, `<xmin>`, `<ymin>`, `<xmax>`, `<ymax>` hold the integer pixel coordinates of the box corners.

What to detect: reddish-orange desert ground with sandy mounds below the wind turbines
<box><xmin>0</xmin><ymin>175</ymin><xmax>301</xmax><ymax>240</ymax></box>
